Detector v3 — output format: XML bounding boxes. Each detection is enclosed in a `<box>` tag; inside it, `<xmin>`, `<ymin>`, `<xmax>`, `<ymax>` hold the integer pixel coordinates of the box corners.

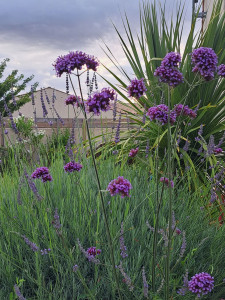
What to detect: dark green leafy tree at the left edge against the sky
<box><xmin>0</xmin><ymin>58</ymin><xmax>37</xmax><ymax>117</ymax></box>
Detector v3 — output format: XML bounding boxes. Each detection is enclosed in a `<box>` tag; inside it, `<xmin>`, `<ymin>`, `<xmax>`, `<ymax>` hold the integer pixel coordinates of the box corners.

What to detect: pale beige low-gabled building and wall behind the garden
<box><xmin>0</xmin><ymin>87</ymin><xmax>136</xmax><ymax>146</ymax></box>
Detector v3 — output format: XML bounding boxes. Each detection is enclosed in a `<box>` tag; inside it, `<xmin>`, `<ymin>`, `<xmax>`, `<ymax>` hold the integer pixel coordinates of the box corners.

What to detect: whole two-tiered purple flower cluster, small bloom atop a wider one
<box><xmin>154</xmin><ymin>52</ymin><xmax>184</xmax><ymax>87</ymax></box>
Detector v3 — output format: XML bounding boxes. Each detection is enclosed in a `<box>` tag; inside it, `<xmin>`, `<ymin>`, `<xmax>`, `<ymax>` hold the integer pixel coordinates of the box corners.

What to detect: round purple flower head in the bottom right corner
<box><xmin>188</xmin><ymin>272</ymin><xmax>214</xmax><ymax>297</ymax></box>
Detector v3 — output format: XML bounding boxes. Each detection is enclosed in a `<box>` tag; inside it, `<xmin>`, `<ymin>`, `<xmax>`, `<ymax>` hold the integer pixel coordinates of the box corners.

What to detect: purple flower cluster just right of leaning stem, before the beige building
<box><xmin>86</xmin><ymin>88</ymin><xmax>116</xmax><ymax>115</ymax></box>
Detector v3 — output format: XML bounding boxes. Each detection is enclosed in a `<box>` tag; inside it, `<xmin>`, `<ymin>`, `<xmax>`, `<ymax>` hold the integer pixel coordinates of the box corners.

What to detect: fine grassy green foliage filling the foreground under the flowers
<box><xmin>0</xmin><ymin>155</ymin><xmax>225</xmax><ymax>300</ymax></box>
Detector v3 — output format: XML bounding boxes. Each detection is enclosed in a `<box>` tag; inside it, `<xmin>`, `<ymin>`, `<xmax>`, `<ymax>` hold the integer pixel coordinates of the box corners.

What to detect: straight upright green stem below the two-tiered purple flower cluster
<box><xmin>165</xmin><ymin>86</ymin><xmax>172</xmax><ymax>300</ymax></box>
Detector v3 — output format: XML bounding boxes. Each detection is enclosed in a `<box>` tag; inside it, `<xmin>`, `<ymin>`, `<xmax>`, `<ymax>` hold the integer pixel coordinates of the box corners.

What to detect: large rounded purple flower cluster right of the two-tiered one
<box><xmin>191</xmin><ymin>47</ymin><xmax>218</xmax><ymax>81</ymax></box>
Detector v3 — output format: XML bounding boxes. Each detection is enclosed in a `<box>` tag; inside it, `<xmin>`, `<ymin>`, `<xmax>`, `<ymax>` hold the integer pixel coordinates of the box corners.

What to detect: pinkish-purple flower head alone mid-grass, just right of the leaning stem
<box><xmin>107</xmin><ymin>176</ymin><xmax>132</xmax><ymax>198</ymax></box>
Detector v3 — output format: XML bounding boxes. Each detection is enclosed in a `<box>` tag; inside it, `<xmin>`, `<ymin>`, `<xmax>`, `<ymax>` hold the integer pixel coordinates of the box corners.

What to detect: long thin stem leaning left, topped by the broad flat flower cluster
<box><xmin>69</xmin><ymin>74</ymin><xmax>122</xmax><ymax>300</ymax></box>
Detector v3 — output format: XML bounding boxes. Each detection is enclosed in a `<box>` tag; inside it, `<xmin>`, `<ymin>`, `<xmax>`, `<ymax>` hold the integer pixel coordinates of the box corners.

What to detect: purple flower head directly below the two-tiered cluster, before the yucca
<box><xmin>146</xmin><ymin>104</ymin><xmax>176</xmax><ymax>125</ymax></box>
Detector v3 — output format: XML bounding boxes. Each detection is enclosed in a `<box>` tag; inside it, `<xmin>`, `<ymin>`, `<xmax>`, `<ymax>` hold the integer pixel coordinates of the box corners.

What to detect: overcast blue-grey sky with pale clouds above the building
<box><xmin>0</xmin><ymin>0</ymin><xmax>200</xmax><ymax>91</ymax></box>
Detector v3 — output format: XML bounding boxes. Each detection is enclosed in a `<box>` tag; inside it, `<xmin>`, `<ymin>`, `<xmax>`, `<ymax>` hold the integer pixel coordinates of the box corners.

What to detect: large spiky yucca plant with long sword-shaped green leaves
<box><xmin>100</xmin><ymin>0</ymin><xmax>225</xmax><ymax>186</ymax></box>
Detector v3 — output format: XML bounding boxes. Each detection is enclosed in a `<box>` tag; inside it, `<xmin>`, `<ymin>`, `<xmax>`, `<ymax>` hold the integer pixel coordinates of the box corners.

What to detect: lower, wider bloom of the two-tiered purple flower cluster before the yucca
<box><xmin>154</xmin><ymin>65</ymin><xmax>184</xmax><ymax>87</ymax></box>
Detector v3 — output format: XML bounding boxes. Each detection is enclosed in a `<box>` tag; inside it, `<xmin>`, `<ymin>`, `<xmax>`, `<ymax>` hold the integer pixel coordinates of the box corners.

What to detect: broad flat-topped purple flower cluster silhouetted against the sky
<box><xmin>53</xmin><ymin>51</ymin><xmax>99</xmax><ymax>77</ymax></box>
